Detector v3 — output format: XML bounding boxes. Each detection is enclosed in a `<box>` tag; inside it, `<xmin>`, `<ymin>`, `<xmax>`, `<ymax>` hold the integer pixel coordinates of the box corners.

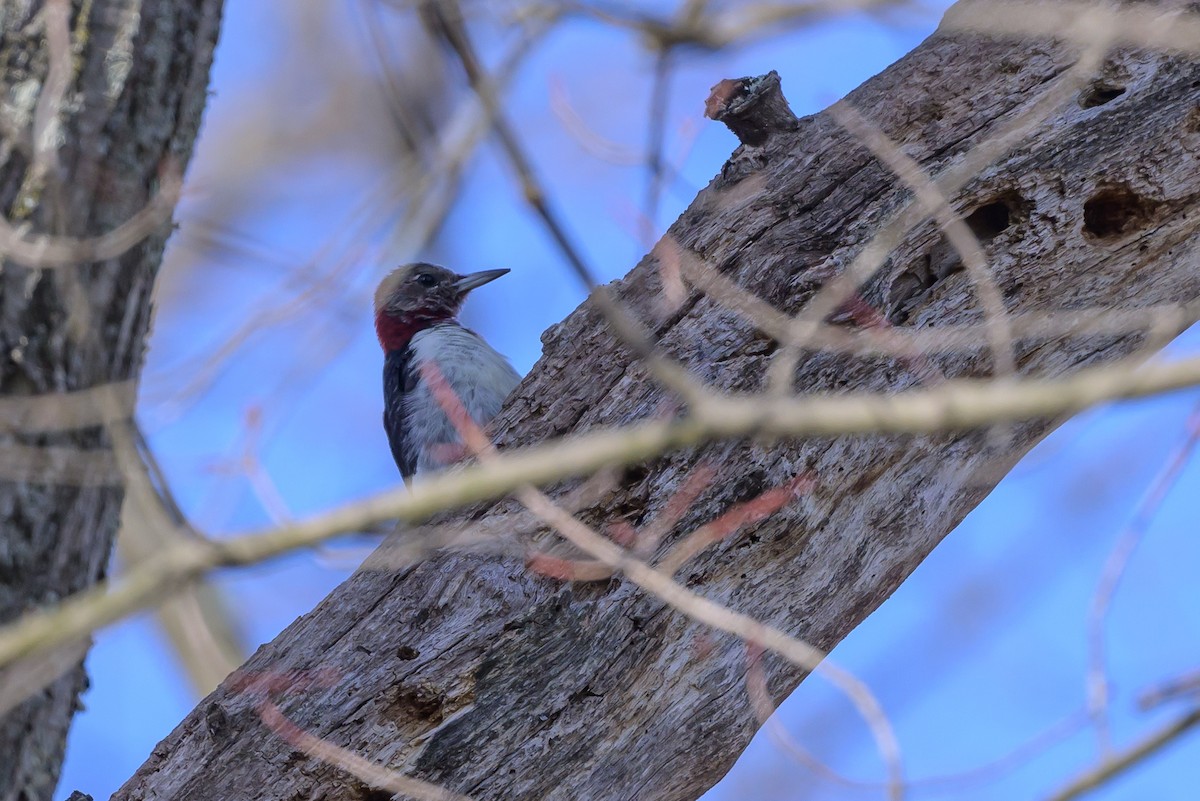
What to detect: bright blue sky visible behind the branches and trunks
<box><xmin>51</xmin><ymin>0</ymin><xmax>1200</xmax><ymax>801</ymax></box>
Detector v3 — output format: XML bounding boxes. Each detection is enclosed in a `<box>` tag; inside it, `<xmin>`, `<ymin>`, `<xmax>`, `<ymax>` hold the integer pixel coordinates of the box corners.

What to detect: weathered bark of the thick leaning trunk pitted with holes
<box><xmin>114</xmin><ymin>9</ymin><xmax>1200</xmax><ymax>800</ymax></box>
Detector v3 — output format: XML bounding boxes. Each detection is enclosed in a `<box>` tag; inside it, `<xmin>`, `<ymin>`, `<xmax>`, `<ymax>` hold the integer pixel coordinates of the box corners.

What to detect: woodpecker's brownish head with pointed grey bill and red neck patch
<box><xmin>376</xmin><ymin>261</ymin><xmax>509</xmax><ymax>350</ymax></box>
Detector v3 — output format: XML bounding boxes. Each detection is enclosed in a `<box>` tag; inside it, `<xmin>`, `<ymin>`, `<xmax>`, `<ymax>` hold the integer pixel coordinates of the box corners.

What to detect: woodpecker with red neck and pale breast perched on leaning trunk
<box><xmin>374</xmin><ymin>263</ymin><xmax>521</xmax><ymax>483</ymax></box>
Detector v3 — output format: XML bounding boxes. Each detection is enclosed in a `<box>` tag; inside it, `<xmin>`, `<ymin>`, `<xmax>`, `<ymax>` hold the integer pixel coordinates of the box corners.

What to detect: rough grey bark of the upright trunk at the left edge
<box><xmin>0</xmin><ymin>0</ymin><xmax>221</xmax><ymax>801</ymax></box>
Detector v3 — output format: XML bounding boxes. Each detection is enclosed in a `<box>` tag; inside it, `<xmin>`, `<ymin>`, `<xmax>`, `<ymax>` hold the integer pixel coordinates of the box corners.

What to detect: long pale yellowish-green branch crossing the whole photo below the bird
<box><xmin>0</xmin><ymin>345</ymin><xmax>1200</xmax><ymax>666</ymax></box>
